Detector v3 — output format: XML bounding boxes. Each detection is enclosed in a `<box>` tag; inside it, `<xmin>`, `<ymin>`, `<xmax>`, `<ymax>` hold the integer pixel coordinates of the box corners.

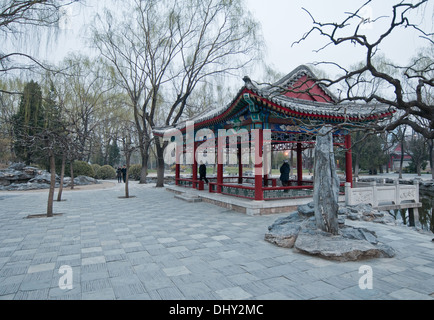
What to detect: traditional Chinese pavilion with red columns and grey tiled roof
<box><xmin>154</xmin><ymin>65</ymin><xmax>392</xmax><ymax>200</ymax></box>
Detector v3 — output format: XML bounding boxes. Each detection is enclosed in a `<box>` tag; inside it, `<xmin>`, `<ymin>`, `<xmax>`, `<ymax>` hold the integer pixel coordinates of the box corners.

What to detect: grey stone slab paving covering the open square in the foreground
<box><xmin>0</xmin><ymin>183</ymin><xmax>434</xmax><ymax>300</ymax></box>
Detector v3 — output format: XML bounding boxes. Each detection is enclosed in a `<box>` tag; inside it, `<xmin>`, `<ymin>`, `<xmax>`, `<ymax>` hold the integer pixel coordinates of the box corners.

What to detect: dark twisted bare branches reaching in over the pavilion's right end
<box><xmin>296</xmin><ymin>0</ymin><xmax>434</xmax><ymax>139</ymax></box>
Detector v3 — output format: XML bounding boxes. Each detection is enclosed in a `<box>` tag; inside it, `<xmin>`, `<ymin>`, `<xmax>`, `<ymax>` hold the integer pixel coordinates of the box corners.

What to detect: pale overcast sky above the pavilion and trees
<box><xmin>34</xmin><ymin>0</ymin><xmax>434</xmax><ymax>81</ymax></box>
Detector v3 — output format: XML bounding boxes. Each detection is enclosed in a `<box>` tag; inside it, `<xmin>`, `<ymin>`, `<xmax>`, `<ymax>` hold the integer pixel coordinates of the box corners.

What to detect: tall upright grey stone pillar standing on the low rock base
<box><xmin>313</xmin><ymin>126</ymin><xmax>339</xmax><ymax>235</ymax></box>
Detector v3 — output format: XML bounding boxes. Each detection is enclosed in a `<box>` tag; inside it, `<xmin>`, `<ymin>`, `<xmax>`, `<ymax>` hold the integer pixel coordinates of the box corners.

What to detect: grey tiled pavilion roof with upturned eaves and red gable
<box><xmin>154</xmin><ymin>65</ymin><xmax>393</xmax><ymax>135</ymax></box>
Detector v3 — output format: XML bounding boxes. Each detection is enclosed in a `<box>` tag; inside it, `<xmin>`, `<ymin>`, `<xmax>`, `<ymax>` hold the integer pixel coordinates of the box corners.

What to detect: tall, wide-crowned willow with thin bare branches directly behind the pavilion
<box><xmin>93</xmin><ymin>0</ymin><xmax>261</xmax><ymax>187</ymax></box>
